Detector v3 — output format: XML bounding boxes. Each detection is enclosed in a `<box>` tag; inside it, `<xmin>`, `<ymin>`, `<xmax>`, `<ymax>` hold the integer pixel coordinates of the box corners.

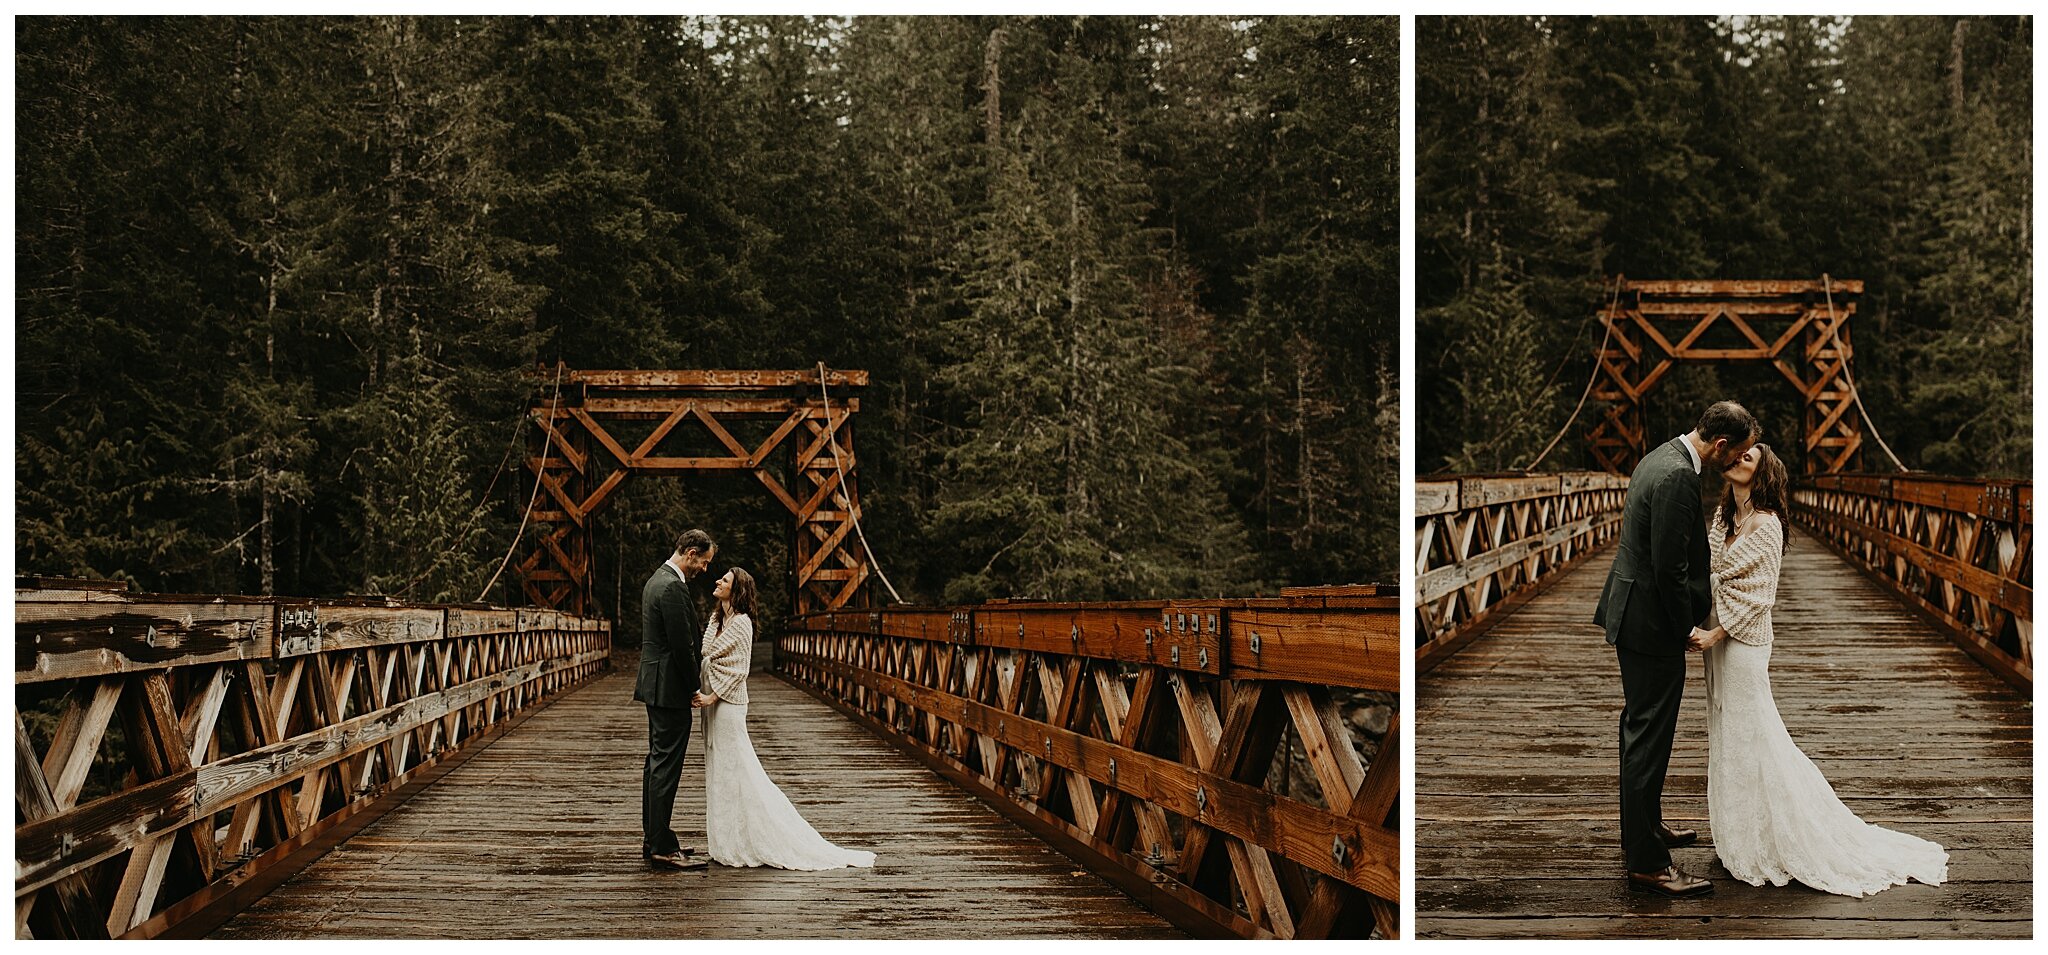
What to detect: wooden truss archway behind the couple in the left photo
<box><xmin>518</xmin><ymin>367</ymin><xmax>868</xmax><ymax>615</ymax></box>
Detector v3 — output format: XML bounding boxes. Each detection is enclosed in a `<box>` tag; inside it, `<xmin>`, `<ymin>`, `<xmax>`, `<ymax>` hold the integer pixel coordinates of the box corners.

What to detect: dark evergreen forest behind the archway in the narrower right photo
<box><xmin>1415</xmin><ymin>16</ymin><xmax>2034</xmax><ymax>478</ymax></box>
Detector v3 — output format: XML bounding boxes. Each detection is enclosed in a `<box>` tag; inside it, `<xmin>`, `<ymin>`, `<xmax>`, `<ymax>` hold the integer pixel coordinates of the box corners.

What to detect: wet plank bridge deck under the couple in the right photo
<box><xmin>1415</xmin><ymin>533</ymin><xmax>2034</xmax><ymax>939</ymax></box>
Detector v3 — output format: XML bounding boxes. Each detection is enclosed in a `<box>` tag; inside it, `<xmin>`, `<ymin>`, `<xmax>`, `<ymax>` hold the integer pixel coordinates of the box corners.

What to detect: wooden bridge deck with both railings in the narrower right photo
<box><xmin>1415</xmin><ymin>471</ymin><xmax>2034</xmax><ymax>939</ymax></box>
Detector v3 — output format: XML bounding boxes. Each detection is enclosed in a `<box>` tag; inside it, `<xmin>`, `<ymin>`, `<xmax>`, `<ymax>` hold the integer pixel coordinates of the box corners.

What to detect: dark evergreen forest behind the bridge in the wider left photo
<box><xmin>14</xmin><ymin>16</ymin><xmax>1400</xmax><ymax>619</ymax></box>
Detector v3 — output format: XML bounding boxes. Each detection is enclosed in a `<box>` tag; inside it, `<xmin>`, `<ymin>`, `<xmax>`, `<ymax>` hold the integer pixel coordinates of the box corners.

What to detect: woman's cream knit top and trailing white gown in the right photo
<box><xmin>1706</xmin><ymin>512</ymin><xmax>1948</xmax><ymax>896</ymax></box>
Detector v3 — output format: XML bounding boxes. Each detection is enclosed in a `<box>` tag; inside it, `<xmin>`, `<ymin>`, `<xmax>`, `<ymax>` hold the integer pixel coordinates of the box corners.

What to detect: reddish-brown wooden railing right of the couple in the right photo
<box><xmin>1792</xmin><ymin>473</ymin><xmax>2034</xmax><ymax>689</ymax></box>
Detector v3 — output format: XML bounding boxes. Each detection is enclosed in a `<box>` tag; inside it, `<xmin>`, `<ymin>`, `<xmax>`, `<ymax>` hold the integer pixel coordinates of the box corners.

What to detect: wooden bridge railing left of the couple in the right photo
<box><xmin>1415</xmin><ymin>471</ymin><xmax>1628</xmax><ymax>672</ymax></box>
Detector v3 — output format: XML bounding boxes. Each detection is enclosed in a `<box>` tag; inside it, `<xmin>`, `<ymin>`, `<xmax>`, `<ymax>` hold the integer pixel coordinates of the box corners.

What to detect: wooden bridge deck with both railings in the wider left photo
<box><xmin>14</xmin><ymin>578</ymin><xmax>1401</xmax><ymax>939</ymax></box>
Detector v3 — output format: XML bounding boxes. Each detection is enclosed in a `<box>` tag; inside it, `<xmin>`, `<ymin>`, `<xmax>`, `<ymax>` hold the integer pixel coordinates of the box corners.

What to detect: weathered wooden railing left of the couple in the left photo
<box><xmin>14</xmin><ymin>578</ymin><xmax>610</xmax><ymax>939</ymax></box>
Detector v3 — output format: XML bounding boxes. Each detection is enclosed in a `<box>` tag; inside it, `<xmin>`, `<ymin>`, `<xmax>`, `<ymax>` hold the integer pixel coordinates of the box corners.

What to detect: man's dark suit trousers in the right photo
<box><xmin>1614</xmin><ymin>648</ymin><xmax>1686</xmax><ymax>873</ymax></box>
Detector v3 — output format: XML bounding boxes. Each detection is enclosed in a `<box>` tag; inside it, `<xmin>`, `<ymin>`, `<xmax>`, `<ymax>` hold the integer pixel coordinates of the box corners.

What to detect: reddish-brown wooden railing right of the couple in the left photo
<box><xmin>776</xmin><ymin>586</ymin><xmax>1401</xmax><ymax>939</ymax></box>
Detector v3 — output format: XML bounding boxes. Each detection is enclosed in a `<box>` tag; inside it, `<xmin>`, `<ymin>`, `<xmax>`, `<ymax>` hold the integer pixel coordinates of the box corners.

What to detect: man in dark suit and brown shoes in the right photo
<box><xmin>1593</xmin><ymin>402</ymin><xmax>1761</xmax><ymax>896</ymax></box>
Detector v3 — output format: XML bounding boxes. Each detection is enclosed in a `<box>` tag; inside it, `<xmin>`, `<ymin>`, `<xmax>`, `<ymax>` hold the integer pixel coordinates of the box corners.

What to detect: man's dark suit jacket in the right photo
<box><xmin>1593</xmin><ymin>437</ymin><xmax>1714</xmax><ymax>656</ymax></box>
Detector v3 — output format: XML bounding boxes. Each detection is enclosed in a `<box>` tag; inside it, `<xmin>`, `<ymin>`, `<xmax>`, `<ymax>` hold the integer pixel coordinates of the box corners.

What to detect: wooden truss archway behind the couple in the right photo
<box><xmin>1589</xmin><ymin>279</ymin><xmax>1864</xmax><ymax>473</ymax></box>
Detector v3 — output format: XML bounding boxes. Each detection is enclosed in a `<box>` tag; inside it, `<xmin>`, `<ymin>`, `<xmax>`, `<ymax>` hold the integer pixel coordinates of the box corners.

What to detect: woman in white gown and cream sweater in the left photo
<box><xmin>692</xmin><ymin>568</ymin><xmax>874</xmax><ymax>869</ymax></box>
